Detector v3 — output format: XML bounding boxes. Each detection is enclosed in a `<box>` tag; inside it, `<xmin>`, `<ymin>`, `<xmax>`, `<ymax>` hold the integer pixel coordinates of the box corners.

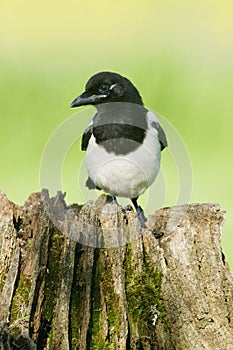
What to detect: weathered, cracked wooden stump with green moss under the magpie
<box><xmin>0</xmin><ymin>191</ymin><xmax>233</xmax><ymax>350</ymax></box>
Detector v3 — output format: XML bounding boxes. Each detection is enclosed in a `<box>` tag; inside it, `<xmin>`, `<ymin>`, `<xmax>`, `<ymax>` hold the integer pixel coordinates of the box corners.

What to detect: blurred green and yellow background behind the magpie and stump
<box><xmin>0</xmin><ymin>0</ymin><xmax>233</xmax><ymax>268</ymax></box>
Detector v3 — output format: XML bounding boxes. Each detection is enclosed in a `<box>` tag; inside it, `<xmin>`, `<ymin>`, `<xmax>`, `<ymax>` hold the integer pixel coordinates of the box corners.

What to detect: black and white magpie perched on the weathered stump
<box><xmin>71</xmin><ymin>72</ymin><xmax>167</xmax><ymax>236</ymax></box>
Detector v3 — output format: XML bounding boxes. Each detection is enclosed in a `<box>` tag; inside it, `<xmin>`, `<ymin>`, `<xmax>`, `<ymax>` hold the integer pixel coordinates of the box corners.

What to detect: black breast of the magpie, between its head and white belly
<box><xmin>92</xmin><ymin>103</ymin><xmax>147</xmax><ymax>155</ymax></box>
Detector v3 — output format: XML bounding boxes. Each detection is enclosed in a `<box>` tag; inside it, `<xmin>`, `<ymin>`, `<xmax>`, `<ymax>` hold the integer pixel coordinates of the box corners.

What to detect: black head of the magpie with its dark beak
<box><xmin>70</xmin><ymin>72</ymin><xmax>143</xmax><ymax>108</ymax></box>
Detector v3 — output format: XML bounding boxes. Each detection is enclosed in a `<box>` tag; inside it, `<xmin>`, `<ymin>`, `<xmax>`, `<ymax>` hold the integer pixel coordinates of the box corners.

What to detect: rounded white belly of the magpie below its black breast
<box><xmin>86</xmin><ymin>133</ymin><xmax>160</xmax><ymax>198</ymax></box>
